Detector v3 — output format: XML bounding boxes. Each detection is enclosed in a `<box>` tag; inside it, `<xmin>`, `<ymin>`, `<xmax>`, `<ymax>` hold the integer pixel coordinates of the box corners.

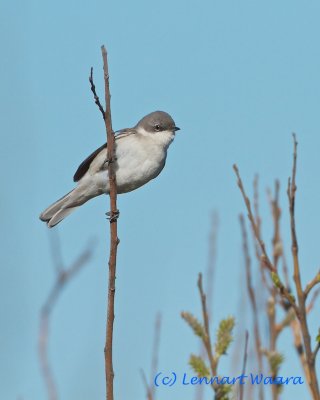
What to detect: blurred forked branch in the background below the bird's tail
<box><xmin>38</xmin><ymin>240</ymin><xmax>95</xmax><ymax>400</ymax></box>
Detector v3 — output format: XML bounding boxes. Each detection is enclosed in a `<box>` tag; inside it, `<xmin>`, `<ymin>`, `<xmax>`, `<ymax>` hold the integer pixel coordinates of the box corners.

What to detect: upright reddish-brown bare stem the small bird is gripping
<box><xmin>101</xmin><ymin>46</ymin><xmax>119</xmax><ymax>400</ymax></box>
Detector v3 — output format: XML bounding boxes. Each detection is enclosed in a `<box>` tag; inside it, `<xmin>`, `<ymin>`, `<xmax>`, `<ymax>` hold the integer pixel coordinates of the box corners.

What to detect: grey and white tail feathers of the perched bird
<box><xmin>39</xmin><ymin>186</ymin><xmax>94</xmax><ymax>228</ymax></box>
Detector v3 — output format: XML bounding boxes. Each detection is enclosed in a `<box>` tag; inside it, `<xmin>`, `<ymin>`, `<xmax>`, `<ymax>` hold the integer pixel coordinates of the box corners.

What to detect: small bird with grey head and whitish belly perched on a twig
<box><xmin>40</xmin><ymin>111</ymin><xmax>180</xmax><ymax>228</ymax></box>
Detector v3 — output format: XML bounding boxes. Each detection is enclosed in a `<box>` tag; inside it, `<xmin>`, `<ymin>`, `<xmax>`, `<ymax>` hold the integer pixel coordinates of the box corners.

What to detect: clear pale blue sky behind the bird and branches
<box><xmin>0</xmin><ymin>0</ymin><xmax>320</xmax><ymax>400</ymax></box>
